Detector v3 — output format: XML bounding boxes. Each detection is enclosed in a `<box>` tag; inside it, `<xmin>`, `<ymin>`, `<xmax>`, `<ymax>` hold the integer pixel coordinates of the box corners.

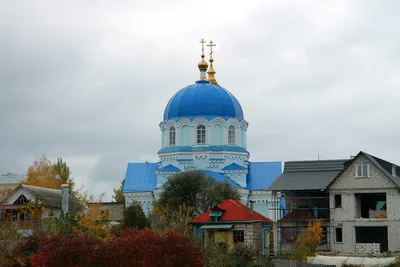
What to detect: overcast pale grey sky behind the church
<box><xmin>0</xmin><ymin>0</ymin><xmax>400</xmax><ymax>198</ymax></box>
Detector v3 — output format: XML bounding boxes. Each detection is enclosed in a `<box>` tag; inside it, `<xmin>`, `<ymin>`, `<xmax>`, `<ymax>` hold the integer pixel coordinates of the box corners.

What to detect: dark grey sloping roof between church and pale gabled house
<box><xmin>267</xmin><ymin>159</ymin><xmax>348</xmax><ymax>191</ymax></box>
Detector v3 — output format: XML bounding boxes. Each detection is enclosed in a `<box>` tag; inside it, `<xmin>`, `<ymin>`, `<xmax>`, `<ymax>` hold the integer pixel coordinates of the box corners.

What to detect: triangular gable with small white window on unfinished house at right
<box><xmin>330</xmin><ymin>154</ymin><xmax>397</xmax><ymax>190</ymax></box>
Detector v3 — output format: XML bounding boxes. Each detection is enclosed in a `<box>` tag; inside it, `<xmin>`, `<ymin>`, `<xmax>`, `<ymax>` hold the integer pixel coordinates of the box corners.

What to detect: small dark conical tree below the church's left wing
<box><xmin>122</xmin><ymin>202</ymin><xmax>150</xmax><ymax>230</ymax></box>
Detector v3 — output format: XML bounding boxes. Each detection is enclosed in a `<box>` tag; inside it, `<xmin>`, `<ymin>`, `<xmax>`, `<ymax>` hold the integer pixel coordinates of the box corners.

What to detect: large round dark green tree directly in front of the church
<box><xmin>157</xmin><ymin>171</ymin><xmax>240</xmax><ymax>214</ymax></box>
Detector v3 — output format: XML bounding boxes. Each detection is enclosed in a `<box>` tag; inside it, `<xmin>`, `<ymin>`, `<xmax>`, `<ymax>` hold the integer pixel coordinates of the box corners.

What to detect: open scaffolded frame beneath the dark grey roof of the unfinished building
<box><xmin>272</xmin><ymin>190</ymin><xmax>330</xmax><ymax>253</ymax></box>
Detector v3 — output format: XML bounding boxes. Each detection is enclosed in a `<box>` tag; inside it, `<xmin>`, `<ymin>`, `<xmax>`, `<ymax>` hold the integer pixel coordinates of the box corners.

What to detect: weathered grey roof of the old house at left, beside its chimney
<box><xmin>20</xmin><ymin>184</ymin><xmax>81</xmax><ymax>210</ymax></box>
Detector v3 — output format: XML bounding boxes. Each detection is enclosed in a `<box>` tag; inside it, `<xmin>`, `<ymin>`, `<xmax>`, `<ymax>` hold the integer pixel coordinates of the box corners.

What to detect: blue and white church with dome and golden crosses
<box><xmin>123</xmin><ymin>40</ymin><xmax>282</xmax><ymax>218</ymax></box>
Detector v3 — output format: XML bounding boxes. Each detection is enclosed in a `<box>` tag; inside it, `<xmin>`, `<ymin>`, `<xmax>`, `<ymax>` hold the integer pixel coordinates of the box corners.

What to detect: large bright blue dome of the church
<box><xmin>164</xmin><ymin>81</ymin><xmax>243</xmax><ymax>121</ymax></box>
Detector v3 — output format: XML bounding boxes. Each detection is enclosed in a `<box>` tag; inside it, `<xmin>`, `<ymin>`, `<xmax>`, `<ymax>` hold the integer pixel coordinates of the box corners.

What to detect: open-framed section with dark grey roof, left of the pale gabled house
<box><xmin>267</xmin><ymin>160</ymin><xmax>348</xmax><ymax>253</ymax></box>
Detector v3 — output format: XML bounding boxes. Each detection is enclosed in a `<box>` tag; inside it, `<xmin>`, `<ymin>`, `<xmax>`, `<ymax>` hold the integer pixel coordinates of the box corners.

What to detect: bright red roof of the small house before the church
<box><xmin>191</xmin><ymin>199</ymin><xmax>272</xmax><ymax>223</ymax></box>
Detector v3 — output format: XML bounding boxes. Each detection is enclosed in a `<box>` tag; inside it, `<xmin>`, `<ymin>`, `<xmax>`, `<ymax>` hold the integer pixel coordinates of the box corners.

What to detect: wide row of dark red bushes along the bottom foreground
<box><xmin>31</xmin><ymin>229</ymin><xmax>204</xmax><ymax>267</ymax></box>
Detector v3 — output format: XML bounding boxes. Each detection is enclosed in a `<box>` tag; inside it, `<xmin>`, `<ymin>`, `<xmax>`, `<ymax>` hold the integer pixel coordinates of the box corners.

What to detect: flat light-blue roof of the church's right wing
<box><xmin>247</xmin><ymin>162</ymin><xmax>282</xmax><ymax>190</ymax></box>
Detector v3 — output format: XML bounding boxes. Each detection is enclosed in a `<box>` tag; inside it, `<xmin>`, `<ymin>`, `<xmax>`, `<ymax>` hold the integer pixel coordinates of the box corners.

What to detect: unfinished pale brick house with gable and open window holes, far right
<box><xmin>329</xmin><ymin>151</ymin><xmax>400</xmax><ymax>253</ymax></box>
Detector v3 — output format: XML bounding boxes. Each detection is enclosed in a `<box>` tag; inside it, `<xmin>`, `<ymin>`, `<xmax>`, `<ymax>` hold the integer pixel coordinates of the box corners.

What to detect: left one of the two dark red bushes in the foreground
<box><xmin>31</xmin><ymin>234</ymin><xmax>103</xmax><ymax>267</ymax></box>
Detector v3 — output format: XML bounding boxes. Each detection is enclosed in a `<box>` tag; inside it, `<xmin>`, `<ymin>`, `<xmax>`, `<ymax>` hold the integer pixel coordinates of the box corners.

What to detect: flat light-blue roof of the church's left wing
<box><xmin>123</xmin><ymin>163</ymin><xmax>157</xmax><ymax>193</ymax></box>
